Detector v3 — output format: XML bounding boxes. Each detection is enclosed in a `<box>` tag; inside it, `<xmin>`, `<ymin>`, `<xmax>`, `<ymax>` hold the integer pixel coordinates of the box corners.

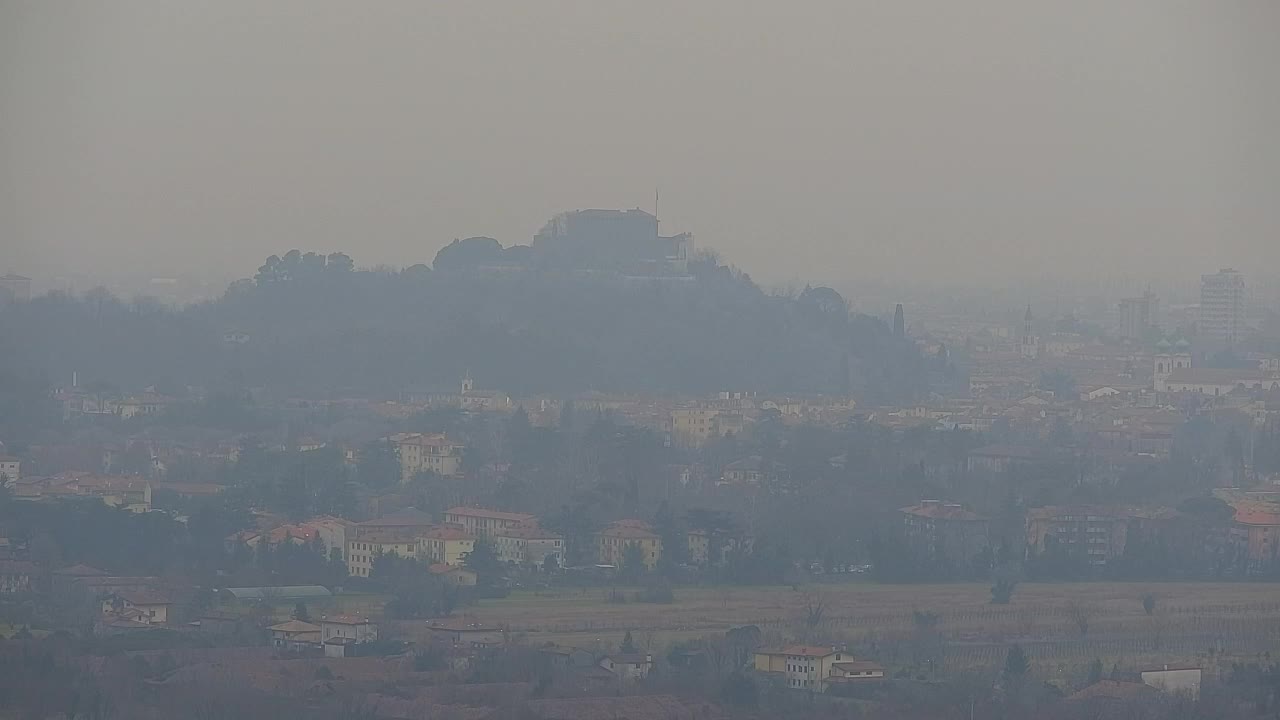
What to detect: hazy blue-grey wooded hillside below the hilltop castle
<box><xmin>0</xmin><ymin>251</ymin><xmax>924</xmax><ymax>401</ymax></box>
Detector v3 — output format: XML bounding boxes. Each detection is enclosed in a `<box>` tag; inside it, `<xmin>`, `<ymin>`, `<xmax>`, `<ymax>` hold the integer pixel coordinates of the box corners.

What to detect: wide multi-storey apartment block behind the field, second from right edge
<box><xmin>1027</xmin><ymin>505</ymin><xmax>1130</xmax><ymax>565</ymax></box>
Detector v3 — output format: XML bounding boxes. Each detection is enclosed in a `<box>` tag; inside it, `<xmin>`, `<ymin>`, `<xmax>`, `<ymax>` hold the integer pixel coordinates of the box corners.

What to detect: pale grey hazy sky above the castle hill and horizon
<box><xmin>0</xmin><ymin>0</ymin><xmax>1280</xmax><ymax>283</ymax></box>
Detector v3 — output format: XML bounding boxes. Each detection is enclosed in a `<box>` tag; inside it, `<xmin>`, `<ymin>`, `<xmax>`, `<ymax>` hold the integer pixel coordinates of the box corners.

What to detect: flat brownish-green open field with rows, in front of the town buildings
<box><xmin>422</xmin><ymin>582</ymin><xmax>1280</xmax><ymax>671</ymax></box>
